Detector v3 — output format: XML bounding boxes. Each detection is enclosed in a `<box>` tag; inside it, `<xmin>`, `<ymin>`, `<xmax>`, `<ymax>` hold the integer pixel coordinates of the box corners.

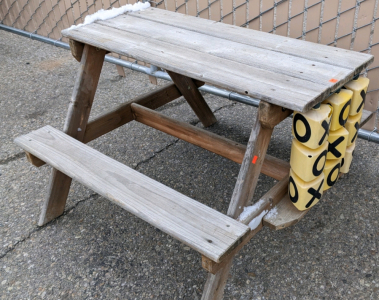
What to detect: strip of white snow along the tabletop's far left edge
<box><xmin>69</xmin><ymin>2</ymin><xmax>150</xmax><ymax>30</ymax></box>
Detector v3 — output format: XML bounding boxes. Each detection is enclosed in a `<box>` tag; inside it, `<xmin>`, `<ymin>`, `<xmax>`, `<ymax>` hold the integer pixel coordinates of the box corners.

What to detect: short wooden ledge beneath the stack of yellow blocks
<box><xmin>263</xmin><ymin>194</ymin><xmax>310</xmax><ymax>230</ymax></box>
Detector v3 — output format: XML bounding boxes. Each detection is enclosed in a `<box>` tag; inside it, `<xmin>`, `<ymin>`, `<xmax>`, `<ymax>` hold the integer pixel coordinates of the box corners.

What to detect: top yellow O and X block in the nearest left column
<box><xmin>292</xmin><ymin>104</ymin><xmax>333</xmax><ymax>149</ymax></box>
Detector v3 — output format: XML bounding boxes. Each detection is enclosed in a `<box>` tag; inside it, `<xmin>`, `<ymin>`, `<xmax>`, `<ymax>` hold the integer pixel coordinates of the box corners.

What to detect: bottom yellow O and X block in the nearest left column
<box><xmin>288</xmin><ymin>170</ymin><xmax>325</xmax><ymax>210</ymax></box>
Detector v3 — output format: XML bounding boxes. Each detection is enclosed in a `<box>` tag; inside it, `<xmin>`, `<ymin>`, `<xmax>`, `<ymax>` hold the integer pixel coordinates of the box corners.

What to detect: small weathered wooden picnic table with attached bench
<box><xmin>16</xmin><ymin>8</ymin><xmax>373</xmax><ymax>299</ymax></box>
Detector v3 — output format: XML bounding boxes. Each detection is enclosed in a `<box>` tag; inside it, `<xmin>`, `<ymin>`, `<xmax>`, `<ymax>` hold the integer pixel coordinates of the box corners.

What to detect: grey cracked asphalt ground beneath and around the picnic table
<box><xmin>0</xmin><ymin>31</ymin><xmax>379</xmax><ymax>300</ymax></box>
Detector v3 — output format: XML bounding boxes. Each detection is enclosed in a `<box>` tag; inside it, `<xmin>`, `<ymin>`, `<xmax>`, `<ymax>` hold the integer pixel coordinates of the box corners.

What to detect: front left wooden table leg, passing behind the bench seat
<box><xmin>38</xmin><ymin>45</ymin><xmax>106</xmax><ymax>226</ymax></box>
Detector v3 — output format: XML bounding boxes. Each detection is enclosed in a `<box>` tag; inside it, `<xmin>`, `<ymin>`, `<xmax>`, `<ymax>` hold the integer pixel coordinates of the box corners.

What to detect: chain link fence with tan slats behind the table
<box><xmin>0</xmin><ymin>0</ymin><xmax>379</xmax><ymax>129</ymax></box>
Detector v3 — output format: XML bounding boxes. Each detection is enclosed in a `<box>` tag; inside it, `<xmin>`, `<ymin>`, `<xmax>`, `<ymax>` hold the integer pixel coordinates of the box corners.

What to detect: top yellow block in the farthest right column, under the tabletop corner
<box><xmin>345</xmin><ymin>77</ymin><xmax>370</xmax><ymax>116</ymax></box>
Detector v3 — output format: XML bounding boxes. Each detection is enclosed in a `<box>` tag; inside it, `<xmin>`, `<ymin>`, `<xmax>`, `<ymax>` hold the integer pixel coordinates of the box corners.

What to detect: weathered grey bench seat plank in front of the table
<box><xmin>15</xmin><ymin>126</ymin><xmax>250</xmax><ymax>262</ymax></box>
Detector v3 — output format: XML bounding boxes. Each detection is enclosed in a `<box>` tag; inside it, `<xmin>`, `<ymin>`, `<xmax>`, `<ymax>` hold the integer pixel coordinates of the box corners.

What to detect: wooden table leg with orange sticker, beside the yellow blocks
<box><xmin>202</xmin><ymin>101</ymin><xmax>292</xmax><ymax>300</ymax></box>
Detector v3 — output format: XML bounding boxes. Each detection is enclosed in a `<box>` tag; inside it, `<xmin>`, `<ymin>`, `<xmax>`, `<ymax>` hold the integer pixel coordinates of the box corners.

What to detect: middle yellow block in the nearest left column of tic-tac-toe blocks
<box><xmin>290</xmin><ymin>139</ymin><xmax>328</xmax><ymax>182</ymax></box>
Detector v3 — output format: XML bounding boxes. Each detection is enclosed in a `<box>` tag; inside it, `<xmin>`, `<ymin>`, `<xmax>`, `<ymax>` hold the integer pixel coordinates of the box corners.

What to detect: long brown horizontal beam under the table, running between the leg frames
<box><xmin>132</xmin><ymin>104</ymin><xmax>289</xmax><ymax>180</ymax></box>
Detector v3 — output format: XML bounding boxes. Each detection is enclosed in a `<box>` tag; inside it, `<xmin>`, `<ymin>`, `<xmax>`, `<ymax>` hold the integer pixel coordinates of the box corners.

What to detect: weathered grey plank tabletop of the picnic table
<box><xmin>62</xmin><ymin>8</ymin><xmax>374</xmax><ymax>111</ymax></box>
